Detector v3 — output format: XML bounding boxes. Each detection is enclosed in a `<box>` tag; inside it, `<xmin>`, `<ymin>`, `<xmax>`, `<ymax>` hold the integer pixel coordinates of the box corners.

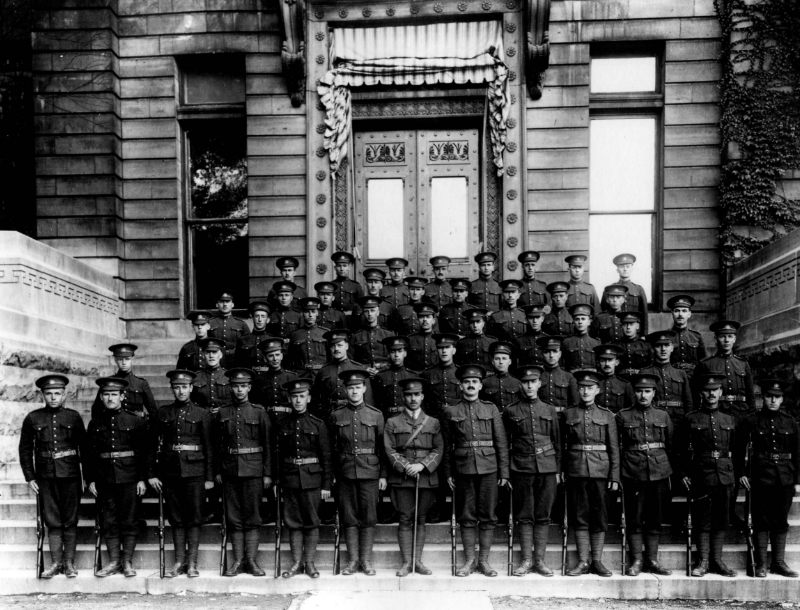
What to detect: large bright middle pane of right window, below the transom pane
<box><xmin>589</xmin><ymin>117</ymin><xmax>656</xmax><ymax>212</ymax></box>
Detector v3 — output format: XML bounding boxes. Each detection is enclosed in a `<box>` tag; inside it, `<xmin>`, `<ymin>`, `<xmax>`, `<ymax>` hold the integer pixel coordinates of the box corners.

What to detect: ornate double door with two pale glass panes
<box><xmin>353</xmin><ymin>128</ymin><xmax>482</xmax><ymax>277</ymax></box>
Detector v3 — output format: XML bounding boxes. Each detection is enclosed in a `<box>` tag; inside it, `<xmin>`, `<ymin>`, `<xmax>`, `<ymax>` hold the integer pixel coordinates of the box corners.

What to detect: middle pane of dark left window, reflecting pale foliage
<box><xmin>188</xmin><ymin>121</ymin><xmax>247</xmax><ymax>218</ymax></box>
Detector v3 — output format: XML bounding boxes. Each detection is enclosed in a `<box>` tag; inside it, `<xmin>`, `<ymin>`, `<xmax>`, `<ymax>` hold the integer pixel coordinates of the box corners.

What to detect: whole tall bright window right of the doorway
<box><xmin>589</xmin><ymin>49</ymin><xmax>663</xmax><ymax>302</ymax></box>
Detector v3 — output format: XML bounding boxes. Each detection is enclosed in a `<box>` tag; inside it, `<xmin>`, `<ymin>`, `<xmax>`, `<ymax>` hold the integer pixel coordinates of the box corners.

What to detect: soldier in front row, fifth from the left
<box><xmin>277</xmin><ymin>379</ymin><xmax>333</xmax><ymax>578</ymax></box>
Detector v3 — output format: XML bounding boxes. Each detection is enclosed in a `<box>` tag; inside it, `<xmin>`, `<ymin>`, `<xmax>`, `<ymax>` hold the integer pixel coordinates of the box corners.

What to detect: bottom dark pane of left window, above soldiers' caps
<box><xmin>191</xmin><ymin>222</ymin><xmax>250</xmax><ymax>310</ymax></box>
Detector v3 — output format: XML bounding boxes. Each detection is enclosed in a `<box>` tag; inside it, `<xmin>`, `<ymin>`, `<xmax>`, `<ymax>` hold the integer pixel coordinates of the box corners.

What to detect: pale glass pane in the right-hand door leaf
<box><xmin>431</xmin><ymin>177</ymin><xmax>469</xmax><ymax>258</ymax></box>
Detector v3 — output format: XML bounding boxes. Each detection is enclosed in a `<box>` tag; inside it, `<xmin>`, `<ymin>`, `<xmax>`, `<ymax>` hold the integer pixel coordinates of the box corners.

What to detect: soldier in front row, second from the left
<box><xmin>83</xmin><ymin>377</ymin><xmax>148</xmax><ymax>578</ymax></box>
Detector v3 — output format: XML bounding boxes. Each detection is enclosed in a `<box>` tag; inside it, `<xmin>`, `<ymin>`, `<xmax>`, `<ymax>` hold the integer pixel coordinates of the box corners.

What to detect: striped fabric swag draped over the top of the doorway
<box><xmin>317</xmin><ymin>21</ymin><xmax>509</xmax><ymax>176</ymax></box>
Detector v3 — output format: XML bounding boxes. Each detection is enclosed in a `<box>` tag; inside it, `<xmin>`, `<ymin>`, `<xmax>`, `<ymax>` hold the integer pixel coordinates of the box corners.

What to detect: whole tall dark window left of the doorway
<box><xmin>178</xmin><ymin>55</ymin><xmax>249</xmax><ymax>308</ymax></box>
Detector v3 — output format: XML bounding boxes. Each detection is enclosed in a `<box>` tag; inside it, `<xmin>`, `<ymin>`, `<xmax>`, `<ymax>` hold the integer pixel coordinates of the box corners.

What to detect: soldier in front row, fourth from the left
<box><xmin>216</xmin><ymin>368</ymin><xmax>272</xmax><ymax>576</ymax></box>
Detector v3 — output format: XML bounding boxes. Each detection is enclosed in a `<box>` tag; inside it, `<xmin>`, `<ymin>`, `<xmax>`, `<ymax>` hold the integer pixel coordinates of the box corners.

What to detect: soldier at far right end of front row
<box><xmin>734</xmin><ymin>379</ymin><xmax>800</xmax><ymax>578</ymax></box>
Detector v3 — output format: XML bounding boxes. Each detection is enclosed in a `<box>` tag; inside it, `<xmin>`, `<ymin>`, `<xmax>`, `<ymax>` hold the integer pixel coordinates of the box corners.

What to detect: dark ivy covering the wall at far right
<box><xmin>714</xmin><ymin>0</ymin><xmax>800</xmax><ymax>264</ymax></box>
